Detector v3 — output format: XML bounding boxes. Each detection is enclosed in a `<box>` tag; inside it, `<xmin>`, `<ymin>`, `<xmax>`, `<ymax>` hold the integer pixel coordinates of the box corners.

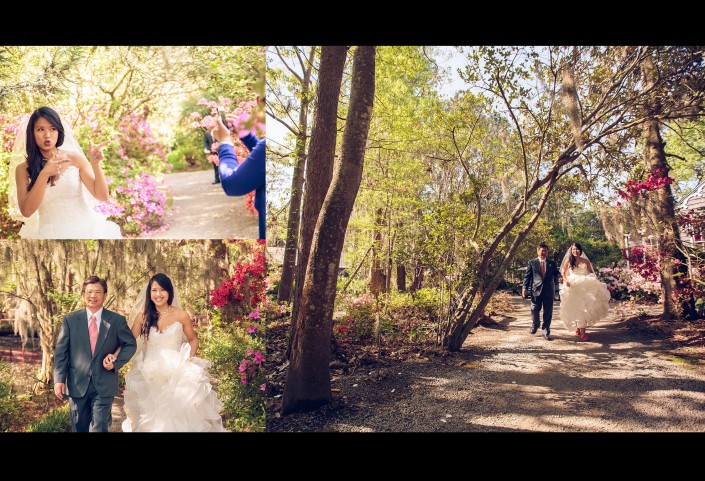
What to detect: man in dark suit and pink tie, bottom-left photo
<box><xmin>54</xmin><ymin>276</ymin><xmax>137</xmax><ymax>432</ymax></box>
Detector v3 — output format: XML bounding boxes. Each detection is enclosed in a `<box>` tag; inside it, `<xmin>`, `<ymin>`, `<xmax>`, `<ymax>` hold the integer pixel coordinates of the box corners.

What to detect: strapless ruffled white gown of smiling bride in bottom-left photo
<box><xmin>122</xmin><ymin>322</ymin><xmax>225</xmax><ymax>432</ymax></box>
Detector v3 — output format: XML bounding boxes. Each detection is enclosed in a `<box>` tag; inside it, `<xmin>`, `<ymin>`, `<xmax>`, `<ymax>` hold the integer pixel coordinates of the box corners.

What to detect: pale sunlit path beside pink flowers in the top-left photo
<box><xmin>148</xmin><ymin>169</ymin><xmax>258</xmax><ymax>239</ymax></box>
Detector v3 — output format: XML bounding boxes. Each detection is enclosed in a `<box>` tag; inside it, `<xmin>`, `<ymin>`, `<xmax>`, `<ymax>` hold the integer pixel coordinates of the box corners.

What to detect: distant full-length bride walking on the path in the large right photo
<box><xmin>560</xmin><ymin>242</ymin><xmax>610</xmax><ymax>341</ymax></box>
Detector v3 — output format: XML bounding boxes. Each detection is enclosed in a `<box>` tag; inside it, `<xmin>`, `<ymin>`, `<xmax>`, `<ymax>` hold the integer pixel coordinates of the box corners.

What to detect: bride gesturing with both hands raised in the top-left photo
<box><xmin>8</xmin><ymin>107</ymin><xmax>122</xmax><ymax>239</ymax></box>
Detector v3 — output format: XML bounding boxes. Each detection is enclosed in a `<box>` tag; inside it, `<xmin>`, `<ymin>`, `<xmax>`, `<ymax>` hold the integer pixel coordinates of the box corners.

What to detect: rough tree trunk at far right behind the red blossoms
<box><xmin>641</xmin><ymin>52</ymin><xmax>697</xmax><ymax>319</ymax></box>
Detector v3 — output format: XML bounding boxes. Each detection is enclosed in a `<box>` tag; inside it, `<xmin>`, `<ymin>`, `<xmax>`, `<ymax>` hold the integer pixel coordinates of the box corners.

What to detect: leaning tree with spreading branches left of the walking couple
<box><xmin>444</xmin><ymin>47</ymin><xmax>702</xmax><ymax>351</ymax></box>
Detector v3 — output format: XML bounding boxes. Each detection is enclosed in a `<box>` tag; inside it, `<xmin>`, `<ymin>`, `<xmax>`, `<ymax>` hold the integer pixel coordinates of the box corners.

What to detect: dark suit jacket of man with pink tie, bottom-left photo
<box><xmin>54</xmin><ymin>308</ymin><xmax>137</xmax><ymax>397</ymax></box>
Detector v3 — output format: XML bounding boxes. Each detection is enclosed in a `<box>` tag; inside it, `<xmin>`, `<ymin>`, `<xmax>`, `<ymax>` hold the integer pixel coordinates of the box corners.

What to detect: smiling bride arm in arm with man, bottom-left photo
<box><xmin>106</xmin><ymin>273</ymin><xmax>225</xmax><ymax>432</ymax></box>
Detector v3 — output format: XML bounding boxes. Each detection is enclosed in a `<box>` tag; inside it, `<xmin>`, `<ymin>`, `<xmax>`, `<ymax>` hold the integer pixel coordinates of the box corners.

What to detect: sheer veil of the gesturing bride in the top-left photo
<box><xmin>7</xmin><ymin>109</ymin><xmax>100</xmax><ymax>232</ymax></box>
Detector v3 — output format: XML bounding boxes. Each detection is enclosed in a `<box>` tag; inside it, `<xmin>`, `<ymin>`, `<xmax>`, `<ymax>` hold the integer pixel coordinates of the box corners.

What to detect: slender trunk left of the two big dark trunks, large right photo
<box><xmin>277</xmin><ymin>47</ymin><xmax>316</xmax><ymax>302</ymax></box>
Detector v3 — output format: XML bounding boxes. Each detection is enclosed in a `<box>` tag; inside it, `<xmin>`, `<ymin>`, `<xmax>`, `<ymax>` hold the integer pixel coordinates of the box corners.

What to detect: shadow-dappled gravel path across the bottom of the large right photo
<box><xmin>267</xmin><ymin>297</ymin><xmax>705</xmax><ymax>431</ymax></box>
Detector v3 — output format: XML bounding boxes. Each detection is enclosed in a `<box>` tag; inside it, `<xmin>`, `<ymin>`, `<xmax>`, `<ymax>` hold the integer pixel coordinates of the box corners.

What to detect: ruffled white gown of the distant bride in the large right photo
<box><xmin>560</xmin><ymin>264</ymin><xmax>610</xmax><ymax>331</ymax></box>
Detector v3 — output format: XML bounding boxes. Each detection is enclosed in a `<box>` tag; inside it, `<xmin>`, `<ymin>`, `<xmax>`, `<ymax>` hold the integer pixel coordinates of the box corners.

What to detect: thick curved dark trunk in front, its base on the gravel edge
<box><xmin>282</xmin><ymin>46</ymin><xmax>375</xmax><ymax>414</ymax></box>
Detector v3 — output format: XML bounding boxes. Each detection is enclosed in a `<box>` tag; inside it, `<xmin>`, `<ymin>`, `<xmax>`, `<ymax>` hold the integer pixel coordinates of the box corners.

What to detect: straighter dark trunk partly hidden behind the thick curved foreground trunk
<box><xmin>289</xmin><ymin>46</ymin><xmax>348</xmax><ymax>351</ymax></box>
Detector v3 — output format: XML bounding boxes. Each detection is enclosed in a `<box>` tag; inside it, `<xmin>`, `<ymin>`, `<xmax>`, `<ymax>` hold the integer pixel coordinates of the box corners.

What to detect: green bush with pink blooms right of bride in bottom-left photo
<box><xmin>201</xmin><ymin>321</ymin><xmax>266</xmax><ymax>432</ymax></box>
